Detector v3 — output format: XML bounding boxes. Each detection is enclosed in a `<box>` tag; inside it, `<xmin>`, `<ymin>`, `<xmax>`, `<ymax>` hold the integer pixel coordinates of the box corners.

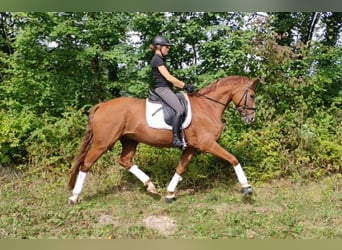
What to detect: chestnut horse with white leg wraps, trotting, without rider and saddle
<box><xmin>69</xmin><ymin>76</ymin><xmax>256</xmax><ymax>203</ymax></box>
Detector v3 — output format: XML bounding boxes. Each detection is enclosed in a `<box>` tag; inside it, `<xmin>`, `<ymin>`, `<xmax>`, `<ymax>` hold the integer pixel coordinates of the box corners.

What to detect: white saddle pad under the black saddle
<box><xmin>146</xmin><ymin>93</ymin><xmax>192</xmax><ymax>130</ymax></box>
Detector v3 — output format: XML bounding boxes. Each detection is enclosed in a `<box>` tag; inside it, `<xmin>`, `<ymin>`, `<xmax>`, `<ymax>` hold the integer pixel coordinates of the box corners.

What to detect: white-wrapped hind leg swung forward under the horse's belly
<box><xmin>119</xmin><ymin>138</ymin><xmax>157</xmax><ymax>194</ymax></box>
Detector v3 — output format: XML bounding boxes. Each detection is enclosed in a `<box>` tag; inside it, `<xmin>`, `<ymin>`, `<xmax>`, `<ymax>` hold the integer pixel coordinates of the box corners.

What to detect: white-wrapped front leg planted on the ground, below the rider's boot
<box><xmin>165</xmin><ymin>148</ymin><xmax>196</xmax><ymax>203</ymax></box>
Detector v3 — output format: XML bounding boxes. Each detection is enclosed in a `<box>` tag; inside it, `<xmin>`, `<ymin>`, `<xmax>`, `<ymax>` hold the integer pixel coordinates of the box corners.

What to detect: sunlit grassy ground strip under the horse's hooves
<box><xmin>0</xmin><ymin>165</ymin><xmax>342</xmax><ymax>239</ymax></box>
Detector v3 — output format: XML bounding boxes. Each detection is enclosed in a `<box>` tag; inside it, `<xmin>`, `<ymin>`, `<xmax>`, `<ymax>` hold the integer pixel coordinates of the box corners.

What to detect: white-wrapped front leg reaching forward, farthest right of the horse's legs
<box><xmin>204</xmin><ymin>142</ymin><xmax>252</xmax><ymax>195</ymax></box>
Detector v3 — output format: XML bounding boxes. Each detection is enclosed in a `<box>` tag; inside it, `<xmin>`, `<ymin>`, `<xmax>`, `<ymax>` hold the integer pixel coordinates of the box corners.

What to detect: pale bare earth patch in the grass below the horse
<box><xmin>143</xmin><ymin>215</ymin><xmax>177</xmax><ymax>236</ymax></box>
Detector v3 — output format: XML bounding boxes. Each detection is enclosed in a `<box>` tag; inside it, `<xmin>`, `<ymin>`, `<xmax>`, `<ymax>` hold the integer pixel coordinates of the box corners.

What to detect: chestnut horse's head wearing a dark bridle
<box><xmin>232</xmin><ymin>79</ymin><xmax>257</xmax><ymax>124</ymax></box>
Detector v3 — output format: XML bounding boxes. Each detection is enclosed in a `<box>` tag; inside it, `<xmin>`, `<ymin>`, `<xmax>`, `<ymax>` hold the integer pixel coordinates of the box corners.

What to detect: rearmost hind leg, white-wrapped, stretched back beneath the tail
<box><xmin>69</xmin><ymin>144</ymin><xmax>107</xmax><ymax>204</ymax></box>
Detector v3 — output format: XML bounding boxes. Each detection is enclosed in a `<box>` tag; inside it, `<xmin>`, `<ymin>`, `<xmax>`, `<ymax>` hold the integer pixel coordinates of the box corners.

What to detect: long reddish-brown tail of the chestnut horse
<box><xmin>68</xmin><ymin>104</ymin><xmax>100</xmax><ymax>190</ymax></box>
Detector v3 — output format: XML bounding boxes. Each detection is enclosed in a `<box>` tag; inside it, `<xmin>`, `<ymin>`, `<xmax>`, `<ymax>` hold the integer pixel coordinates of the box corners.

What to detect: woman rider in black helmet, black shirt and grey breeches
<box><xmin>150</xmin><ymin>36</ymin><xmax>194</xmax><ymax>147</ymax></box>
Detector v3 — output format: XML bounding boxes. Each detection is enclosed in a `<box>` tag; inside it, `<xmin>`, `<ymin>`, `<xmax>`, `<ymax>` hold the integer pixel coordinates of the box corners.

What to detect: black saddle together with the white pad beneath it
<box><xmin>146</xmin><ymin>89</ymin><xmax>191</xmax><ymax>130</ymax></box>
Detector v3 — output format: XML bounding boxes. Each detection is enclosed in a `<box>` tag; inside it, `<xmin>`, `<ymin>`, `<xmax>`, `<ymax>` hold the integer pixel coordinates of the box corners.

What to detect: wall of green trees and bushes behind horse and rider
<box><xmin>0</xmin><ymin>12</ymin><xmax>342</xmax><ymax>191</ymax></box>
